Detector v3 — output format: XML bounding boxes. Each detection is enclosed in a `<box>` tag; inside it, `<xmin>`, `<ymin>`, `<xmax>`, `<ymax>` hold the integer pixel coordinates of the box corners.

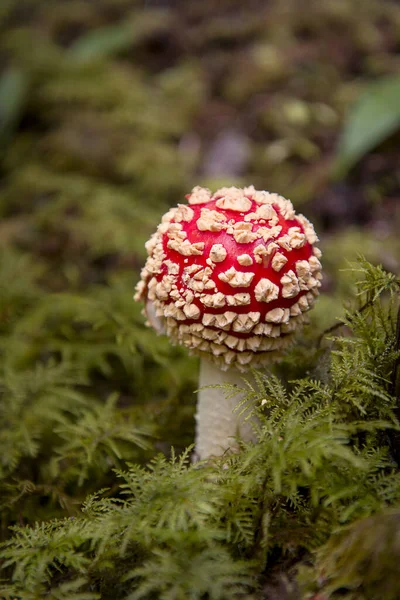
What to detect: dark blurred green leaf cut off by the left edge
<box><xmin>0</xmin><ymin>67</ymin><xmax>28</xmax><ymax>145</ymax></box>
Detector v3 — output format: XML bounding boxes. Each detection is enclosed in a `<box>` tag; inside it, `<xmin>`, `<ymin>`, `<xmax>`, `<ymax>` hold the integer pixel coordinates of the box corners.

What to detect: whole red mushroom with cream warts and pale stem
<box><xmin>135</xmin><ymin>186</ymin><xmax>322</xmax><ymax>459</ymax></box>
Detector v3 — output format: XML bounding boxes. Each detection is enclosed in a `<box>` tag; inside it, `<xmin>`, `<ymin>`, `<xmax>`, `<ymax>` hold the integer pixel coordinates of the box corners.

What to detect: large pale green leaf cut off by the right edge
<box><xmin>334</xmin><ymin>75</ymin><xmax>400</xmax><ymax>177</ymax></box>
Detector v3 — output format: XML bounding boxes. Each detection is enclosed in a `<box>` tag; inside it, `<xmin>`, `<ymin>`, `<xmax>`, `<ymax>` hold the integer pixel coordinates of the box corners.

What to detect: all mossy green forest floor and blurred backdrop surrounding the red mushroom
<box><xmin>0</xmin><ymin>0</ymin><xmax>400</xmax><ymax>600</ymax></box>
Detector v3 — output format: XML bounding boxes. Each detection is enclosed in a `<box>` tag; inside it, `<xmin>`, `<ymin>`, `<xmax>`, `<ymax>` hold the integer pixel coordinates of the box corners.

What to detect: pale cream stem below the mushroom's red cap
<box><xmin>196</xmin><ymin>358</ymin><xmax>255</xmax><ymax>460</ymax></box>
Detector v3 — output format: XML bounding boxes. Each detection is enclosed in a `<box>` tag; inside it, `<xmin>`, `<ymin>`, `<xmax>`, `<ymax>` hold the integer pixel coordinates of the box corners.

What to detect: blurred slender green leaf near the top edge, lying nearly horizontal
<box><xmin>68</xmin><ymin>25</ymin><xmax>132</xmax><ymax>63</ymax></box>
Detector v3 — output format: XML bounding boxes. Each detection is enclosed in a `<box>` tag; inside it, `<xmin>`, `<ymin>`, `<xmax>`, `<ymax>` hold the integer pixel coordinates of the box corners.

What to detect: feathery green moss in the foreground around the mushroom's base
<box><xmin>1</xmin><ymin>261</ymin><xmax>400</xmax><ymax>600</ymax></box>
